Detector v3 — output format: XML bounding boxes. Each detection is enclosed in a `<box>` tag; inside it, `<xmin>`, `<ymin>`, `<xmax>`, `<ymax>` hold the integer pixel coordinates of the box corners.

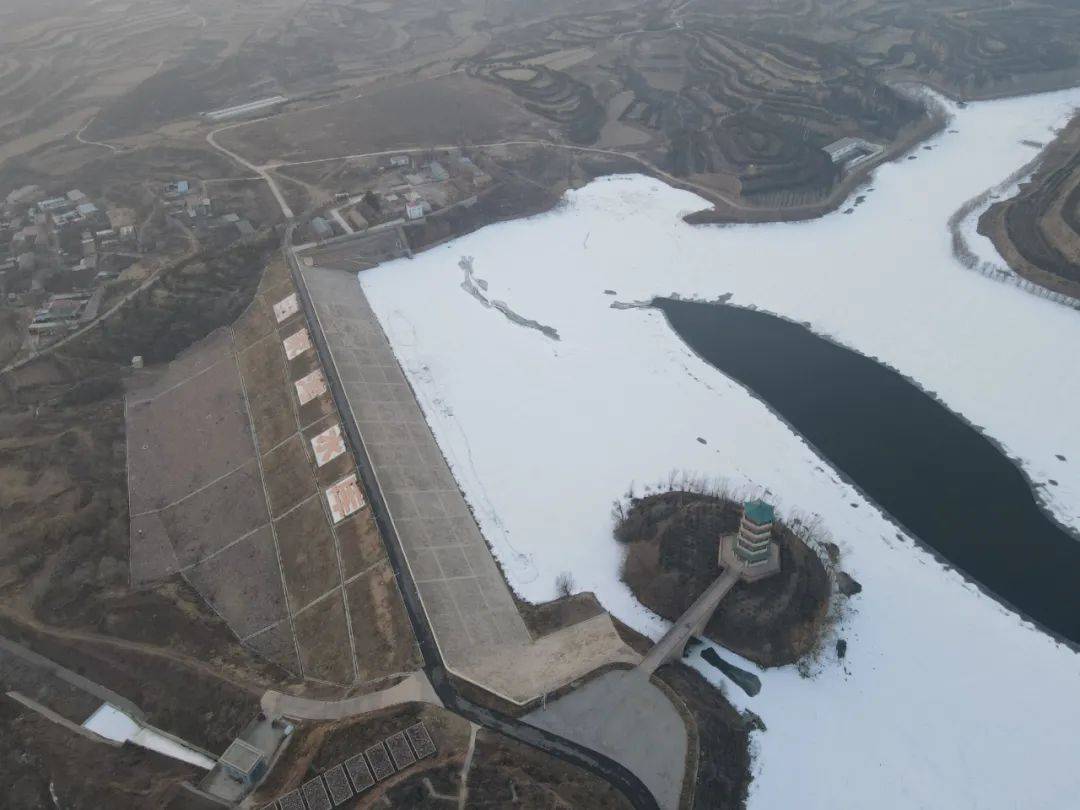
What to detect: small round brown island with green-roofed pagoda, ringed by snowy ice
<box><xmin>615</xmin><ymin>490</ymin><xmax>832</xmax><ymax>666</ymax></box>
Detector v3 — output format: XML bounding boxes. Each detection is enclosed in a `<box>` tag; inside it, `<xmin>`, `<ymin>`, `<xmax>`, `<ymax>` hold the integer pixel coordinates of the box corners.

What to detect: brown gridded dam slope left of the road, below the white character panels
<box><xmin>127</xmin><ymin>273</ymin><xmax>388</xmax><ymax>684</ymax></box>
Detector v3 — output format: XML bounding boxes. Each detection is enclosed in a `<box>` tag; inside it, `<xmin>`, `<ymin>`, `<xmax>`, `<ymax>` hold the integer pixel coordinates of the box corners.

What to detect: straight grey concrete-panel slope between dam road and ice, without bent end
<box><xmin>305</xmin><ymin>270</ymin><xmax>531</xmax><ymax>670</ymax></box>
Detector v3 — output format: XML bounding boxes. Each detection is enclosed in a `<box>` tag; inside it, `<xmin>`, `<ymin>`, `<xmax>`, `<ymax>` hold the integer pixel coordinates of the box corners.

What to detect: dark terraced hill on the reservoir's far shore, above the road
<box><xmin>469</xmin><ymin>10</ymin><xmax>922</xmax><ymax>205</ymax></box>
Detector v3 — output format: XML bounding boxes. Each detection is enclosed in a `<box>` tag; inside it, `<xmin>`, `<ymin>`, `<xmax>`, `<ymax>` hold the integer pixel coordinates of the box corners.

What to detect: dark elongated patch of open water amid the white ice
<box><xmin>656</xmin><ymin>299</ymin><xmax>1080</xmax><ymax>643</ymax></box>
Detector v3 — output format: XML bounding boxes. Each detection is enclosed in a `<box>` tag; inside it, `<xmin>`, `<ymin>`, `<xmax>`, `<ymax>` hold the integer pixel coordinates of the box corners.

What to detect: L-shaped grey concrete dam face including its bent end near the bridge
<box><xmin>301</xmin><ymin>262</ymin><xmax>640</xmax><ymax>704</ymax></box>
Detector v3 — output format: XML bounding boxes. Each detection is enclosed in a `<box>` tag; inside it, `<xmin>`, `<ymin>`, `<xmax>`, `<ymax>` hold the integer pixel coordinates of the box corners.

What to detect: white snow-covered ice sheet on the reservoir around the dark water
<box><xmin>362</xmin><ymin>91</ymin><xmax>1080</xmax><ymax>809</ymax></box>
